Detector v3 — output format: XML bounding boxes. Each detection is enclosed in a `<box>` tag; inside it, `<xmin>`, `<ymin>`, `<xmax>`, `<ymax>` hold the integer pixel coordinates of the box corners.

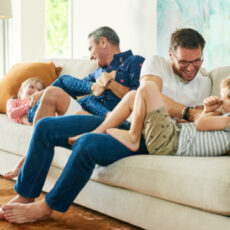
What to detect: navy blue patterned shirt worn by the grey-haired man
<box><xmin>84</xmin><ymin>50</ymin><xmax>144</xmax><ymax>110</ymax></box>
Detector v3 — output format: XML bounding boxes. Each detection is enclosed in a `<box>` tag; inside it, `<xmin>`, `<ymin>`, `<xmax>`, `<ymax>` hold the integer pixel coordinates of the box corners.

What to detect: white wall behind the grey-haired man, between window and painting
<box><xmin>73</xmin><ymin>0</ymin><xmax>157</xmax><ymax>57</ymax></box>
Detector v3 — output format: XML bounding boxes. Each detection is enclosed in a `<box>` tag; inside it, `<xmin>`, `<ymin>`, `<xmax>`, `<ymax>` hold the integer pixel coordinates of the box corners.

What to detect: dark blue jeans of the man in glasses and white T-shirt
<box><xmin>15</xmin><ymin>115</ymin><xmax>147</xmax><ymax>212</ymax></box>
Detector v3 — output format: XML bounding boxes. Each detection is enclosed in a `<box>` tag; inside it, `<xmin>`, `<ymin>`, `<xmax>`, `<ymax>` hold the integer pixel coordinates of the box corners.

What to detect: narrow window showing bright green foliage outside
<box><xmin>45</xmin><ymin>0</ymin><xmax>71</xmax><ymax>57</ymax></box>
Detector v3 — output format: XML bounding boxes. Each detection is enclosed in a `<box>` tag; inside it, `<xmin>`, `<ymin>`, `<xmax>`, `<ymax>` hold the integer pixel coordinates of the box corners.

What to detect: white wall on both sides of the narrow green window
<box><xmin>9</xmin><ymin>0</ymin><xmax>157</xmax><ymax>67</ymax></box>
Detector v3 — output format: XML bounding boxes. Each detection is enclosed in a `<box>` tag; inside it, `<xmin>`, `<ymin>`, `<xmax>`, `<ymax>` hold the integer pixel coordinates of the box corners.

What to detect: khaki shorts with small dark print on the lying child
<box><xmin>143</xmin><ymin>107</ymin><xmax>180</xmax><ymax>155</ymax></box>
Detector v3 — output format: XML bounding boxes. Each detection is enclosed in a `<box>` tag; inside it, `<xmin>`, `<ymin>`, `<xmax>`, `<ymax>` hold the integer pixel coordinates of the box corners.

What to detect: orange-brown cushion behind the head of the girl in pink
<box><xmin>0</xmin><ymin>62</ymin><xmax>61</xmax><ymax>113</ymax></box>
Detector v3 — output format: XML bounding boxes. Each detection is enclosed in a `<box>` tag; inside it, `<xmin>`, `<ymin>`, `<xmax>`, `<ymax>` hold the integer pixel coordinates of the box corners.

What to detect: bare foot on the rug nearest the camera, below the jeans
<box><xmin>2</xmin><ymin>199</ymin><xmax>52</xmax><ymax>224</ymax></box>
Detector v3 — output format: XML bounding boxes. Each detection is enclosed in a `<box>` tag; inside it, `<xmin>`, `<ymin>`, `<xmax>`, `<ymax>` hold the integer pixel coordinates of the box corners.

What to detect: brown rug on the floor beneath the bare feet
<box><xmin>0</xmin><ymin>176</ymin><xmax>140</xmax><ymax>230</ymax></box>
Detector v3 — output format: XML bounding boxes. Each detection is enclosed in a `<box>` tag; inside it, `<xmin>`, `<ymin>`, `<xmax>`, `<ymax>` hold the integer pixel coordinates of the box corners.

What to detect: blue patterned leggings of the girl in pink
<box><xmin>27</xmin><ymin>74</ymin><xmax>110</xmax><ymax>123</ymax></box>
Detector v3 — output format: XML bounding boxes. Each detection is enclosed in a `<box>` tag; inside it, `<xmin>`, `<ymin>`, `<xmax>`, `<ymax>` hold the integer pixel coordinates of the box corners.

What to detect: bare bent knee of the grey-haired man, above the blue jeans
<box><xmin>33</xmin><ymin>86</ymin><xmax>70</xmax><ymax>125</ymax></box>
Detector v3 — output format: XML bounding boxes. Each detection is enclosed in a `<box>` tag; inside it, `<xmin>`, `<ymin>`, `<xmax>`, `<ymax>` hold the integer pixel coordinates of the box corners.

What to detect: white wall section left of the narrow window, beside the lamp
<box><xmin>9</xmin><ymin>0</ymin><xmax>45</xmax><ymax>66</ymax></box>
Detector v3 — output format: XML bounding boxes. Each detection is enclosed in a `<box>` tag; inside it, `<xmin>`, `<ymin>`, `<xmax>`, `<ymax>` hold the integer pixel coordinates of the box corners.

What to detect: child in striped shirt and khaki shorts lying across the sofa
<box><xmin>69</xmin><ymin>76</ymin><xmax>230</xmax><ymax>156</ymax></box>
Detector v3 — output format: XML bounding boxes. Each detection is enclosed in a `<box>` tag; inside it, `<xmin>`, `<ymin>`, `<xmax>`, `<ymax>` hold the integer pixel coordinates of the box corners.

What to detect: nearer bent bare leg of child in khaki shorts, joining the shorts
<box><xmin>106</xmin><ymin>81</ymin><xmax>164</xmax><ymax>151</ymax></box>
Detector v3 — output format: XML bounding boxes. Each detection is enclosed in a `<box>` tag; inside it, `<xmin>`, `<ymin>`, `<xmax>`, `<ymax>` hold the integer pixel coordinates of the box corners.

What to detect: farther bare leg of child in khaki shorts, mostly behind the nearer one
<box><xmin>68</xmin><ymin>91</ymin><xmax>136</xmax><ymax>145</ymax></box>
